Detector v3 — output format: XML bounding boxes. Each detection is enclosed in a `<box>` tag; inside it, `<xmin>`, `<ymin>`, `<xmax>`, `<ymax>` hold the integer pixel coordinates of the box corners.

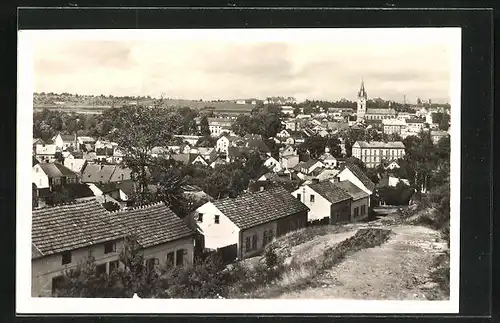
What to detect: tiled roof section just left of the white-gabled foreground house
<box><xmin>108</xmin><ymin>203</ymin><xmax>194</xmax><ymax>248</ymax></box>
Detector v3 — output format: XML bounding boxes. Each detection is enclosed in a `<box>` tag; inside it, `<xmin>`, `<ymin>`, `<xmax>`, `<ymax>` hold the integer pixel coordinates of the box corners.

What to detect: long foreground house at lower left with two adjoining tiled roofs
<box><xmin>31</xmin><ymin>200</ymin><xmax>194</xmax><ymax>297</ymax></box>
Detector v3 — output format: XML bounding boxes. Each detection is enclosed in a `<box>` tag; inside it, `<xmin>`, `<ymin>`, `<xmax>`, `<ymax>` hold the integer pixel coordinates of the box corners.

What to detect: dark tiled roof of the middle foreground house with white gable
<box><xmin>212</xmin><ymin>187</ymin><xmax>309</xmax><ymax>229</ymax></box>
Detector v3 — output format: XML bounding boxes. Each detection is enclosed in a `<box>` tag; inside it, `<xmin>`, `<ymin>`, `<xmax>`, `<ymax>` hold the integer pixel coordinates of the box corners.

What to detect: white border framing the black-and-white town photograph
<box><xmin>16</xmin><ymin>27</ymin><xmax>461</xmax><ymax>314</ymax></box>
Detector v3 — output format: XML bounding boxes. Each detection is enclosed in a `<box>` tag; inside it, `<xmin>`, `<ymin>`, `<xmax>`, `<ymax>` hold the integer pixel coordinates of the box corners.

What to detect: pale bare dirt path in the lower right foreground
<box><xmin>280</xmin><ymin>226</ymin><xmax>446</xmax><ymax>300</ymax></box>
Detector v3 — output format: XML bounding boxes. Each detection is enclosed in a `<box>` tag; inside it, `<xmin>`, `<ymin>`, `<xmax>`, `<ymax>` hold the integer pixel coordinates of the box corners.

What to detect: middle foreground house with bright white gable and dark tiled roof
<box><xmin>191</xmin><ymin>187</ymin><xmax>309</xmax><ymax>259</ymax></box>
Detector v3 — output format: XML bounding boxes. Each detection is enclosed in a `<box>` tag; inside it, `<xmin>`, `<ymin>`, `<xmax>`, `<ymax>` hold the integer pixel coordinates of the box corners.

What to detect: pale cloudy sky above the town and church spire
<box><xmin>33</xmin><ymin>28</ymin><xmax>457</xmax><ymax>103</ymax></box>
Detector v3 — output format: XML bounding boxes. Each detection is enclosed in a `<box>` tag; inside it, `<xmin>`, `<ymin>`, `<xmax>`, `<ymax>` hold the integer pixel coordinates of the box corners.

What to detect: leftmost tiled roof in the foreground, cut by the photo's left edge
<box><xmin>31</xmin><ymin>200</ymin><xmax>123</xmax><ymax>256</ymax></box>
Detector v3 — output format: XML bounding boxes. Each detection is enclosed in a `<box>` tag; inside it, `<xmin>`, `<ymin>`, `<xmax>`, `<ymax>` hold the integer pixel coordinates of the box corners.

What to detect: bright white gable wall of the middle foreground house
<box><xmin>195</xmin><ymin>202</ymin><xmax>240</xmax><ymax>249</ymax></box>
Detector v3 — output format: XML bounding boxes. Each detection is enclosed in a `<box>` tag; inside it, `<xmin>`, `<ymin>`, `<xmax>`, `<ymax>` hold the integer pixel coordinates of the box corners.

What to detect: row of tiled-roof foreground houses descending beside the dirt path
<box><xmin>32</xmin><ymin>160</ymin><xmax>380</xmax><ymax>296</ymax></box>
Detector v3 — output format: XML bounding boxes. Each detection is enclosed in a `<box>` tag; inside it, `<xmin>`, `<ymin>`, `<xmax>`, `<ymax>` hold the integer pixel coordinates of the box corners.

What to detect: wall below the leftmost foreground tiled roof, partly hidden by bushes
<box><xmin>31</xmin><ymin>241</ymin><xmax>123</xmax><ymax>297</ymax></box>
